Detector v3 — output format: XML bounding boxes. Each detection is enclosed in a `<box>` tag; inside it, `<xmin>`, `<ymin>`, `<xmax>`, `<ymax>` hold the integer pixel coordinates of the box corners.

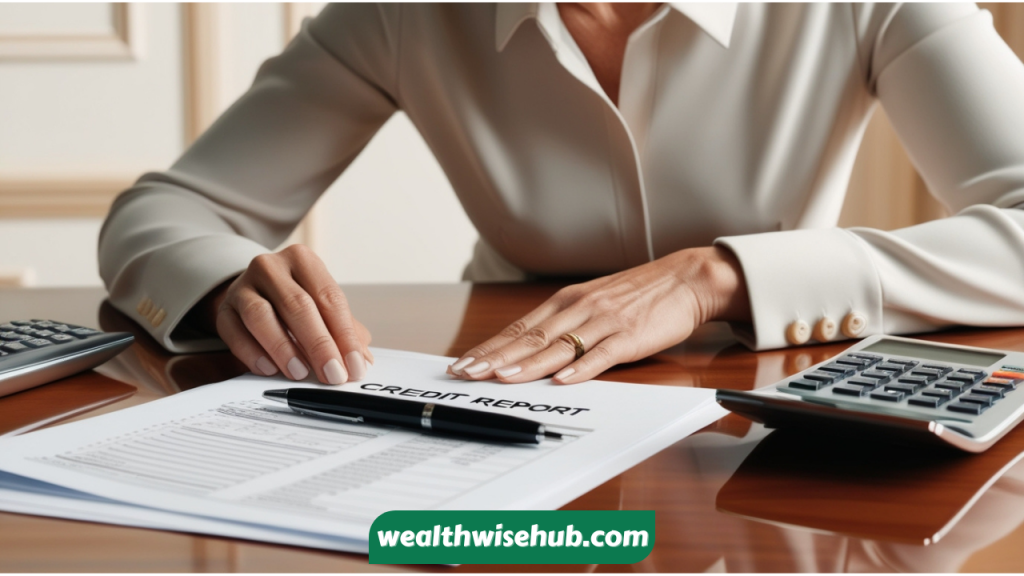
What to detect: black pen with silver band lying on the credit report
<box><xmin>263</xmin><ymin>388</ymin><xmax>562</xmax><ymax>444</ymax></box>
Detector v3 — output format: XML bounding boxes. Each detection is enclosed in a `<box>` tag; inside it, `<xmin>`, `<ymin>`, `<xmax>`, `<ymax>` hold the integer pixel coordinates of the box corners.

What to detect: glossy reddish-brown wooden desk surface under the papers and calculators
<box><xmin>0</xmin><ymin>284</ymin><xmax>1024</xmax><ymax>572</ymax></box>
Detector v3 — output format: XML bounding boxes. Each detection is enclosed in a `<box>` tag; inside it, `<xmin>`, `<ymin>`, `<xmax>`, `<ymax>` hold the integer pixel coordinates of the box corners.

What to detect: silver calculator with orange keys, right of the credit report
<box><xmin>717</xmin><ymin>336</ymin><xmax>1024</xmax><ymax>452</ymax></box>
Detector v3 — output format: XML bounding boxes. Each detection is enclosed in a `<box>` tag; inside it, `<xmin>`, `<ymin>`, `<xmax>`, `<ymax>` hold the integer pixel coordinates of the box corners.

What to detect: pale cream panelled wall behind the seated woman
<box><xmin>6</xmin><ymin>3</ymin><xmax>1024</xmax><ymax>286</ymax></box>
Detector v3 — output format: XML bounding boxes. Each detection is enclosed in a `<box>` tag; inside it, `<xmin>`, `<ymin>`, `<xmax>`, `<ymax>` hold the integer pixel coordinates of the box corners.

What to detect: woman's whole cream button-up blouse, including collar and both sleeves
<box><xmin>99</xmin><ymin>4</ymin><xmax>1024</xmax><ymax>352</ymax></box>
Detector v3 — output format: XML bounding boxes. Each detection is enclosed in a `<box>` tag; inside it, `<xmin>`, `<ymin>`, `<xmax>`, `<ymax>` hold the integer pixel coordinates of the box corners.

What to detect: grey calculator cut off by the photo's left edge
<box><xmin>0</xmin><ymin>320</ymin><xmax>135</xmax><ymax>396</ymax></box>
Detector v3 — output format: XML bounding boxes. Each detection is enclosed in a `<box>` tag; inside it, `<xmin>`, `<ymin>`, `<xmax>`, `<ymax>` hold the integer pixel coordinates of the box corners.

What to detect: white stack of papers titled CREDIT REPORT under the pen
<box><xmin>0</xmin><ymin>348</ymin><xmax>726</xmax><ymax>552</ymax></box>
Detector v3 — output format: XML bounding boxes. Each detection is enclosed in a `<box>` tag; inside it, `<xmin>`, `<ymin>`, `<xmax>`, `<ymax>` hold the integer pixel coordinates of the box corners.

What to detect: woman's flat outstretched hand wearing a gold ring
<box><xmin>450</xmin><ymin>247</ymin><xmax>751</xmax><ymax>384</ymax></box>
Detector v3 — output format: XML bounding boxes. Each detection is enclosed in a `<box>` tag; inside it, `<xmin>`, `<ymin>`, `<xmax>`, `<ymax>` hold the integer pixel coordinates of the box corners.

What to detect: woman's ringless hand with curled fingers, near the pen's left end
<box><xmin>201</xmin><ymin>244</ymin><xmax>373</xmax><ymax>384</ymax></box>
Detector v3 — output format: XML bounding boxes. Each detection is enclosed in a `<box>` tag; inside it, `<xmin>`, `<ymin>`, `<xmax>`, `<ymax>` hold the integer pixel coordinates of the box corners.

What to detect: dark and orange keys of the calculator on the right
<box><xmin>782</xmin><ymin>352</ymin><xmax>1024</xmax><ymax>415</ymax></box>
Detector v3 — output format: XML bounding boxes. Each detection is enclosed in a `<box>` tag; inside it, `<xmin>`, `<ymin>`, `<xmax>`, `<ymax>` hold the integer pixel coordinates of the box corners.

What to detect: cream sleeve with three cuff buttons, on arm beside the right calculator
<box><xmin>717</xmin><ymin>4</ymin><xmax>1024</xmax><ymax>349</ymax></box>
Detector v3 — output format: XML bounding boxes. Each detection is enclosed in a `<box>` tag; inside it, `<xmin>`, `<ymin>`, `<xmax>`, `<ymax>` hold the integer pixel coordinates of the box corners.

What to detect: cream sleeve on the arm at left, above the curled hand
<box><xmin>99</xmin><ymin>4</ymin><xmax>400</xmax><ymax>352</ymax></box>
